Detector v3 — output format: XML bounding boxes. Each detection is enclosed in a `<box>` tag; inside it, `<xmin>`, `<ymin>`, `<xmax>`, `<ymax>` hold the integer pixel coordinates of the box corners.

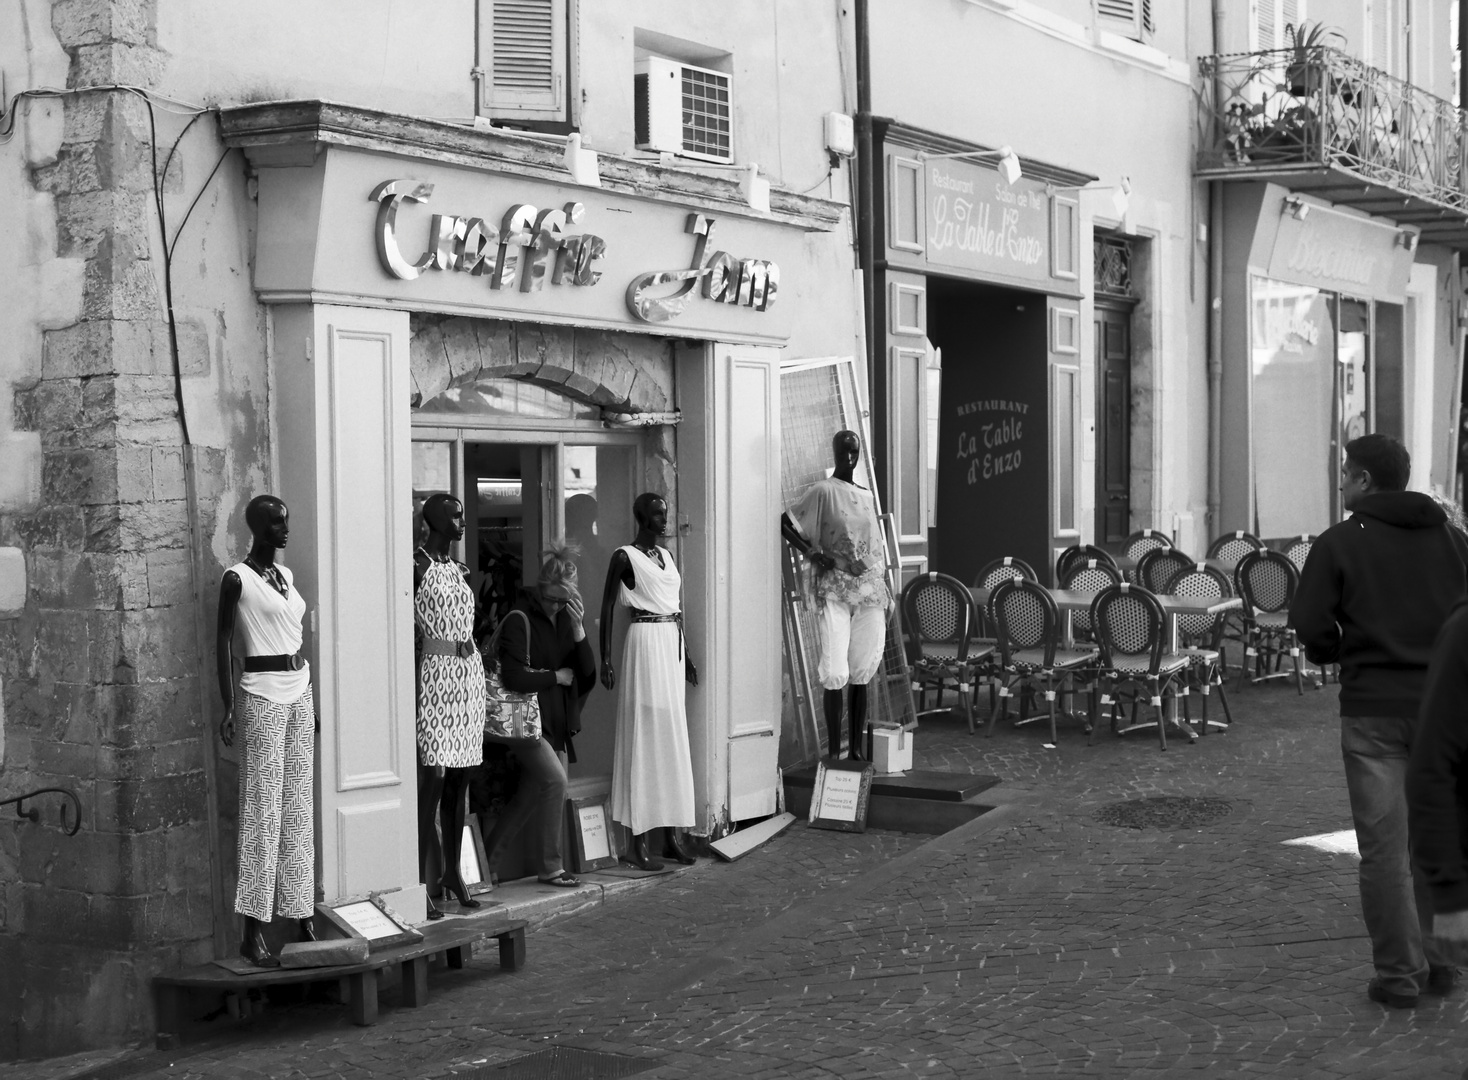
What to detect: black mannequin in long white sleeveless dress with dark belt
<box><xmin>600</xmin><ymin>492</ymin><xmax>699</xmax><ymax>870</ymax></box>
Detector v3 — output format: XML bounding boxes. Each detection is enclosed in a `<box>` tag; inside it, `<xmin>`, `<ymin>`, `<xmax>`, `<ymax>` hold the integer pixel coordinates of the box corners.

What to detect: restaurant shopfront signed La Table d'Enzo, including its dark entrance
<box><xmin>873</xmin><ymin>123</ymin><xmax>1095</xmax><ymax>581</ymax></box>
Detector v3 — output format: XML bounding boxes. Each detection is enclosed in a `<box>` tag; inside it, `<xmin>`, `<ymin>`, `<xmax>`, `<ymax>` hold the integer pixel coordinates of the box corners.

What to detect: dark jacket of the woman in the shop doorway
<box><xmin>499</xmin><ymin>588</ymin><xmax>596</xmax><ymax>762</ymax></box>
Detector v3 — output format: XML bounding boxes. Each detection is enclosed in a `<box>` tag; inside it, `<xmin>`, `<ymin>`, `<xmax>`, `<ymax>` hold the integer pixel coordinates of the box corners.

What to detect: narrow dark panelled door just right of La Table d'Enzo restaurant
<box><xmin>1095</xmin><ymin>304</ymin><xmax>1132</xmax><ymax>546</ymax></box>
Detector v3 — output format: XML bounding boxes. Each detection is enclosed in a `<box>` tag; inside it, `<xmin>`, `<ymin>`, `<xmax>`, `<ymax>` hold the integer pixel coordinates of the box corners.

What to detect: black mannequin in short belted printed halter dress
<box><xmin>413</xmin><ymin>495</ymin><xmax>484</xmax><ymax>919</ymax></box>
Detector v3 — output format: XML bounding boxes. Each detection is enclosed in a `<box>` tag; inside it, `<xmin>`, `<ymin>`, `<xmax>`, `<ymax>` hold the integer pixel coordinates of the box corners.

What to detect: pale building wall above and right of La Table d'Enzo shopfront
<box><xmin>872</xmin><ymin>0</ymin><xmax>1208</xmax><ymax>550</ymax></box>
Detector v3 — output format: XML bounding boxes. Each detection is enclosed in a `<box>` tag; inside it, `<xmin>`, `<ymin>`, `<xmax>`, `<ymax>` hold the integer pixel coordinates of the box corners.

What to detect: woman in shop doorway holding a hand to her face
<box><xmin>484</xmin><ymin>544</ymin><xmax>596</xmax><ymax>888</ymax></box>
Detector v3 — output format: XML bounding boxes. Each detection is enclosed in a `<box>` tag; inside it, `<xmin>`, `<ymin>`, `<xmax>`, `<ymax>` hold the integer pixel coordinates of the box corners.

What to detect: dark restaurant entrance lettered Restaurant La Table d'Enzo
<box><xmin>928</xmin><ymin>277</ymin><xmax>1051</xmax><ymax>584</ymax></box>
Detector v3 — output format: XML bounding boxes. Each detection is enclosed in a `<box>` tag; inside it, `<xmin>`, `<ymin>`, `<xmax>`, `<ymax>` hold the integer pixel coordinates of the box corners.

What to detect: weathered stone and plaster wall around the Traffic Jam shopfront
<box><xmin>0</xmin><ymin>0</ymin><xmax>859</xmax><ymax>1059</ymax></box>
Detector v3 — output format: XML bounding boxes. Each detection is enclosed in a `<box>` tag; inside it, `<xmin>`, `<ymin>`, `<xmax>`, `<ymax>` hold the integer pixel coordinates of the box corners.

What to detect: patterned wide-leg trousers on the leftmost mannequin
<box><xmin>235</xmin><ymin>687</ymin><xmax>316</xmax><ymax>923</ymax></box>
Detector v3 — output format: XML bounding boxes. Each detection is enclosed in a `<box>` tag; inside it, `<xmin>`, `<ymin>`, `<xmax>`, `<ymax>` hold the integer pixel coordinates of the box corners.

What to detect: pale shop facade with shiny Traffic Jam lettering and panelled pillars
<box><xmin>223</xmin><ymin>103</ymin><xmax>850</xmax><ymax>919</ymax></box>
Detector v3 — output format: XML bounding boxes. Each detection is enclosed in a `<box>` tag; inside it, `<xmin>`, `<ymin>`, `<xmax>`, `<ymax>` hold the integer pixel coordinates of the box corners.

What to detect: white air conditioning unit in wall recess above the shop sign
<box><xmin>633</xmin><ymin>56</ymin><xmax>734</xmax><ymax>161</ymax></box>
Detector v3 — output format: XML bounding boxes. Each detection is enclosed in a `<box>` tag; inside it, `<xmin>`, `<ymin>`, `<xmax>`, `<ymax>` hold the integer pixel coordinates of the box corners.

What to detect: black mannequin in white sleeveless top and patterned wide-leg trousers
<box><xmin>216</xmin><ymin>495</ymin><xmax>316</xmax><ymax>967</ymax></box>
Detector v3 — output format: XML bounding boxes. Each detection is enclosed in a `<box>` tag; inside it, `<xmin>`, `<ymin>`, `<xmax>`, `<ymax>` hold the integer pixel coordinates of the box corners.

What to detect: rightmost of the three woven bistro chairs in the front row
<box><xmin>1091</xmin><ymin>581</ymin><xmax>1198</xmax><ymax>750</ymax></box>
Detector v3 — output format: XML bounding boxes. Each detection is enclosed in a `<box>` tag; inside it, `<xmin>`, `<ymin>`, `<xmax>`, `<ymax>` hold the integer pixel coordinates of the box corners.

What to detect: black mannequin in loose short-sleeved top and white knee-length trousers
<box><xmin>780</xmin><ymin>431</ymin><xmax>893</xmax><ymax>762</ymax></box>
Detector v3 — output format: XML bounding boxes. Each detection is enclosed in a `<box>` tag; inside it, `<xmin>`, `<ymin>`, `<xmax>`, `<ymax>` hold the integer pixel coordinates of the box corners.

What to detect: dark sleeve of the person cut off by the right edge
<box><xmin>1406</xmin><ymin>603</ymin><xmax>1468</xmax><ymax>929</ymax></box>
